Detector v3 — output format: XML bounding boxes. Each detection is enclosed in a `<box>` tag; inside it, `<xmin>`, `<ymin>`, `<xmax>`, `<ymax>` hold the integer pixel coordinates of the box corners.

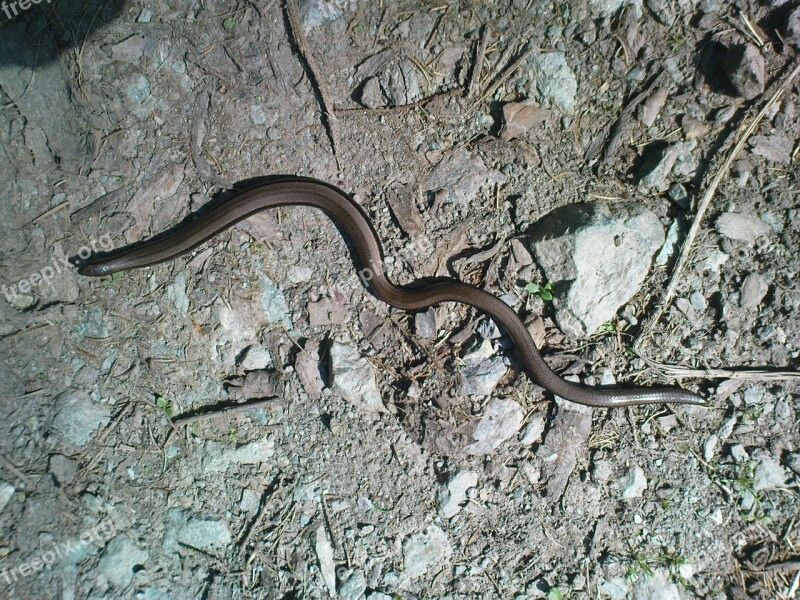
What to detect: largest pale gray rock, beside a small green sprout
<box><xmin>531</xmin><ymin>202</ymin><xmax>664</xmax><ymax>338</ymax></box>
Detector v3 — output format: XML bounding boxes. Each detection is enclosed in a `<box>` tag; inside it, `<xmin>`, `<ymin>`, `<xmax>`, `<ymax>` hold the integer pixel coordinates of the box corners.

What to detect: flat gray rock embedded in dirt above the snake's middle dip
<box><xmin>423</xmin><ymin>148</ymin><xmax>506</xmax><ymax>207</ymax></box>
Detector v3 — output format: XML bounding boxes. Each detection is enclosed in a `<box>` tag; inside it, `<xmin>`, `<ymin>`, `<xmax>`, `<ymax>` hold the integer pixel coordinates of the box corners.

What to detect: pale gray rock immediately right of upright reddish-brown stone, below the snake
<box><xmin>330</xmin><ymin>342</ymin><xmax>386</xmax><ymax>412</ymax></box>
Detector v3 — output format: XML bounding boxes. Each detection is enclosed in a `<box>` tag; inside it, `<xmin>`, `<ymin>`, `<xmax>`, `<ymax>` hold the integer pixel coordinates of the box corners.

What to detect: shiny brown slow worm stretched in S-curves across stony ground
<box><xmin>78</xmin><ymin>177</ymin><xmax>704</xmax><ymax>408</ymax></box>
